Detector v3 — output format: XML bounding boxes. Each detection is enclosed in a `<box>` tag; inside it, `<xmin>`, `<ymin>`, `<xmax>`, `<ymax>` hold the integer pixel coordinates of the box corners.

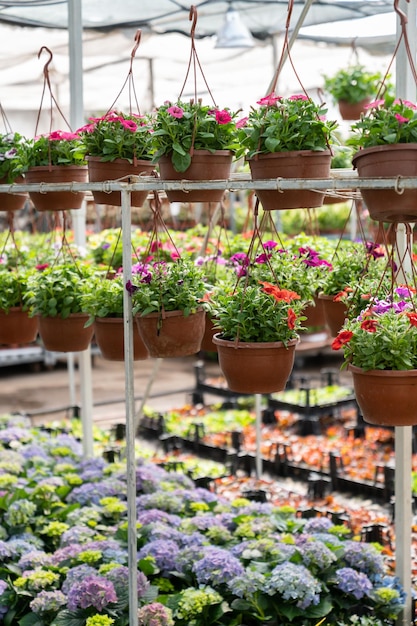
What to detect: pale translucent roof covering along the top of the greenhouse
<box><xmin>0</xmin><ymin>0</ymin><xmax>393</xmax><ymax>39</ymax></box>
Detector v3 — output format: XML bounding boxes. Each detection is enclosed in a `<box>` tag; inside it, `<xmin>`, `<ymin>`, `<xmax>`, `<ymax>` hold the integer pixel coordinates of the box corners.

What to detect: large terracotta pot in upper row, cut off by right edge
<box><xmin>352</xmin><ymin>143</ymin><xmax>417</xmax><ymax>223</ymax></box>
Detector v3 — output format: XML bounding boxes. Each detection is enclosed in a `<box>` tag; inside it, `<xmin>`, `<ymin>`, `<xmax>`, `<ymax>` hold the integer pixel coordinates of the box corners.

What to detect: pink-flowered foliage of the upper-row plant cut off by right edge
<box><xmin>346</xmin><ymin>96</ymin><xmax>417</xmax><ymax>149</ymax></box>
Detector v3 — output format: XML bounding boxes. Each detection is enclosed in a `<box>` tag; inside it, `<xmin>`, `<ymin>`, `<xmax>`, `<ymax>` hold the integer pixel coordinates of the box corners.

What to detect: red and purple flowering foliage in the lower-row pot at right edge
<box><xmin>332</xmin><ymin>285</ymin><xmax>417</xmax><ymax>371</ymax></box>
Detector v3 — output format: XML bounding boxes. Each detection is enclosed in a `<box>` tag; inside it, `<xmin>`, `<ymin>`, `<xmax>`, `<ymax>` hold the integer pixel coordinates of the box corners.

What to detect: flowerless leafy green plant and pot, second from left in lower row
<box><xmin>24</xmin><ymin>263</ymin><xmax>93</xmax><ymax>352</ymax></box>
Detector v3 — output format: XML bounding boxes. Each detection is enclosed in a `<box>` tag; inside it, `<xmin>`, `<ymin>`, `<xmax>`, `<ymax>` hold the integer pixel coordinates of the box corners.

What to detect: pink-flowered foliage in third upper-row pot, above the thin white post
<box><xmin>77</xmin><ymin>111</ymin><xmax>153</xmax><ymax>163</ymax></box>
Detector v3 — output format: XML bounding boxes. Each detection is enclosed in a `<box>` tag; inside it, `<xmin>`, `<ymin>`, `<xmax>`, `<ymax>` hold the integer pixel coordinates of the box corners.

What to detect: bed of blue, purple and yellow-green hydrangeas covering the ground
<box><xmin>0</xmin><ymin>416</ymin><xmax>404</xmax><ymax>626</ymax></box>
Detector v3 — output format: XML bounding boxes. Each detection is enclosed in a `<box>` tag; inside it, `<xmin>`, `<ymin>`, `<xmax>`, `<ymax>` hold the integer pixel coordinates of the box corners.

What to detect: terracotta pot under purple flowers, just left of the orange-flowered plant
<box><xmin>136</xmin><ymin>309</ymin><xmax>206</xmax><ymax>358</ymax></box>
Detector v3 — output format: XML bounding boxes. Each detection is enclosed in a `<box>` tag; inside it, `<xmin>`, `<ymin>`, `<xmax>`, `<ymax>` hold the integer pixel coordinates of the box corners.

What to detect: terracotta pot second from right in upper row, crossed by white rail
<box><xmin>248</xmin><ymin>150</ymin><xmax>331</xmax><ymax>211</ymax></box>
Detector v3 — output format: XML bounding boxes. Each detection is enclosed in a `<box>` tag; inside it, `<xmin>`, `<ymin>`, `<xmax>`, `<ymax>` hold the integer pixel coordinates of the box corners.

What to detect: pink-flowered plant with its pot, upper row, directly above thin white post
<box><xmin>77</xmin><ymin>111</ymin><xmax>154</xmax><ymax>207</ymax></box>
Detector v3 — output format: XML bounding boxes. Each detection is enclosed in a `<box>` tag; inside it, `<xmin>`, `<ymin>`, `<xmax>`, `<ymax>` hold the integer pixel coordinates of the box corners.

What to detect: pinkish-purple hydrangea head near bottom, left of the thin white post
<box><xmin>68</xmin><ymin>575</ymin><xmax>117</xmax><ymax>611</ymax></box>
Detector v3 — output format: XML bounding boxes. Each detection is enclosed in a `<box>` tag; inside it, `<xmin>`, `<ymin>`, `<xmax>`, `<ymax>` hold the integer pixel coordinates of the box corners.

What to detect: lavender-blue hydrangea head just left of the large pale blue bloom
<box><xmin>193</xmin><ymin>546</ymin><xmax>245</xmax><ymax>586</ymax></box>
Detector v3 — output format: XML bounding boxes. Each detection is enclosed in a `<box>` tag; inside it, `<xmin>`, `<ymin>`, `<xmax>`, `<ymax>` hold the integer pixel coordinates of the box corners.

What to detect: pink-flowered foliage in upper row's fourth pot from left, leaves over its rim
<box><xmin>152</xmin><ymin>101</ymin><xmax>242</xmax><ymax>172</ymax></box>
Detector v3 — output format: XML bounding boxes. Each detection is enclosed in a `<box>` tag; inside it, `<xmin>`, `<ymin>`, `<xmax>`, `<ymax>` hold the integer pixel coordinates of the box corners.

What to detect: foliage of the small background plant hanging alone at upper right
<box><xmin>324</xmin><ymin>65</ymin><xmax>383</xmax><ymax>104</ymax></box>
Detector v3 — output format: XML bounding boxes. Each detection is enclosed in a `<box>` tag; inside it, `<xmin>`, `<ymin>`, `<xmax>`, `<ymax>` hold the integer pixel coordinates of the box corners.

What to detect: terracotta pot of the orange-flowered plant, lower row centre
<box><xmin>213</xmin><ymin>334</ymin><xmax>298</xmax><ymax>393</ymax></box>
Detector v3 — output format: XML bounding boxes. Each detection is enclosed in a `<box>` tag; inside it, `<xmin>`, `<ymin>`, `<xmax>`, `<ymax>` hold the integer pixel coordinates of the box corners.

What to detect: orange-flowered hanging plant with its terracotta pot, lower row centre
<box><xmin>209</xmin><ymin>278</ymin><xmax>305</xmax><ymax>393</ymax></box>
